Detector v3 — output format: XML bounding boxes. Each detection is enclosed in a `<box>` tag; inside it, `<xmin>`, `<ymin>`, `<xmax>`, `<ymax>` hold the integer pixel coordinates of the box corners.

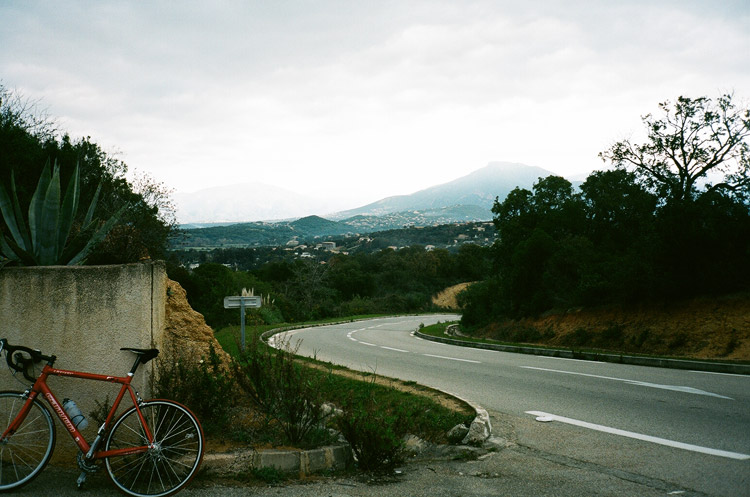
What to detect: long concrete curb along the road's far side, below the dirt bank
<box><xmin>416</xmin><ymin>331</ymin><xmax>750</xmax><ymax>374</ymax></box>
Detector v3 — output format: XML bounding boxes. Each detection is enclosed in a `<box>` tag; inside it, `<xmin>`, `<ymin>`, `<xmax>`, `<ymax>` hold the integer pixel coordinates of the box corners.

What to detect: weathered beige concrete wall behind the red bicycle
<box><xmin>0</xmin><ymin>262</ymin><xmax>167</xmax><ymax>462</ymax></box>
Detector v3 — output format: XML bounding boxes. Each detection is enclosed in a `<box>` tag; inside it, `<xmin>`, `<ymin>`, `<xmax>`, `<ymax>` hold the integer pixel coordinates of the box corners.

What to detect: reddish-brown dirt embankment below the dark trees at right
<box><xmin>480</xmin><ymin>294</ymin><xmax>750</xmax><ymax>361</ymax></box>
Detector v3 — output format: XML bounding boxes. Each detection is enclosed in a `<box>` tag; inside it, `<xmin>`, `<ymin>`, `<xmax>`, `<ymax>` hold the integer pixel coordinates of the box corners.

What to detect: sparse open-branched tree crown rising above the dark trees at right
<box><xmin>599</xmin><ymin>95</ymin><xmax>750</xmax><ymax>202</ymax></box>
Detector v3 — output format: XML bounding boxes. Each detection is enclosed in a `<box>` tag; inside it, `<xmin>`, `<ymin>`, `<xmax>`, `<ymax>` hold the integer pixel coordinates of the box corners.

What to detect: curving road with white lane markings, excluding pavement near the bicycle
<box><xmin>276</xmin><ymin>314</ymin><xmax>750</xmax><ymax>496</ymax></box>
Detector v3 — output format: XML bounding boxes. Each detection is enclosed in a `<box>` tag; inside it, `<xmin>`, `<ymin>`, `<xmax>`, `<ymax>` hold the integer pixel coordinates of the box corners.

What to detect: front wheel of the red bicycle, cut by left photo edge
<box><xmin>0</xmin><ymin>392</ymin><xmax>55</xmax><ymax>492</ymax></box>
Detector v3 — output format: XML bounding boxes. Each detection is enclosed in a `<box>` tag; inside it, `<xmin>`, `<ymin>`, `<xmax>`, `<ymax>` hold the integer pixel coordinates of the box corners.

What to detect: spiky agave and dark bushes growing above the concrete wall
<box><xmin>0</xmin><ymin>83</ymin><xmax>176</xmax><ymax>267</ymax></box>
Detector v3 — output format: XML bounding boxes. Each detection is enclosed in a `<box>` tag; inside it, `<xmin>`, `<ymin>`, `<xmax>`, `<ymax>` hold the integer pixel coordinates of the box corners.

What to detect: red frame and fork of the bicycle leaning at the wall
<box><xmin>0</xmin><ymin>364</ymin><xmax>154</xmax><ymax>459</ymax></box>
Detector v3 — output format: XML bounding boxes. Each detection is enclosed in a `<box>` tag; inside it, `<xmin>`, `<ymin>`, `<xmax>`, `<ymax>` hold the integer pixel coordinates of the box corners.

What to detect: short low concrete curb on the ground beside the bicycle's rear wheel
<box><xmin>202</xmin><ymin>444</ymin><xmax>352</xmax><ymax>478</ymax></box>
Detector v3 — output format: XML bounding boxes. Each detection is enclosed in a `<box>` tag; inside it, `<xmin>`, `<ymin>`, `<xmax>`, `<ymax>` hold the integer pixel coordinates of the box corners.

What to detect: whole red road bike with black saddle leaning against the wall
<box><xmin>0</xmin><ymin>338</ymin><xmax>204</xmax><ymax>496</ymax></box>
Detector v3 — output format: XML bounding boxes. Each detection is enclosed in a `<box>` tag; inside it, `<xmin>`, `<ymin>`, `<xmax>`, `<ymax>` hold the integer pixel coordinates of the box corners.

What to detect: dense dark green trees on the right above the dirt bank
<box><xmin>460</xmin><ymin>95</ymin><xmax>750</xmax><ymax>338</ymax></box>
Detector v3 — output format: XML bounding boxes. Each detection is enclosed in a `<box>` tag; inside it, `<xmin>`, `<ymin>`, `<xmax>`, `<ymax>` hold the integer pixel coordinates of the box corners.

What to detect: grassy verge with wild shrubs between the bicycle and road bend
<box><xmin>154</xmin><ymin>328</ymin><xmax>474</xmax><ymax>471</ymax></box>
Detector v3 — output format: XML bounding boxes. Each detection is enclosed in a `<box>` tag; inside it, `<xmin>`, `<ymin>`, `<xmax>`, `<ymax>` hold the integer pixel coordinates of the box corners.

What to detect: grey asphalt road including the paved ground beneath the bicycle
<box><xmin>22</xmin><ymin>315</ymin><xmax>750</xmax><ymax>497</ymax></box>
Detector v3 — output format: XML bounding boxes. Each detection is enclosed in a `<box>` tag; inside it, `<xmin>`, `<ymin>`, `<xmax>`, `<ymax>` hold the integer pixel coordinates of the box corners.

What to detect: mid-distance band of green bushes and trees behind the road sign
<box><xmin>168</xmin><ymin>245</ymin><xmax>491</xmax><ymax>329</ymax></box>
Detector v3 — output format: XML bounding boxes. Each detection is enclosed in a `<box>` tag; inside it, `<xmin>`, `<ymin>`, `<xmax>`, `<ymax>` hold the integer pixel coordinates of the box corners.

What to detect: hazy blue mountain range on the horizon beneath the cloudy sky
<box><xmin>180</xmin><ymin>162</ymin><xmax>564</xmax><ymax>247</ymax></box>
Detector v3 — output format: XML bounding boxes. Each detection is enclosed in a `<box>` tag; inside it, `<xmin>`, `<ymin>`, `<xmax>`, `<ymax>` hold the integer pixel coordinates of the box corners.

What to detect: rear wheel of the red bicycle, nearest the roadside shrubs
<box><xmin>104</xmin><ymin>400</ymin><xmax>205</xmax><ymax>497</ymax></box>
